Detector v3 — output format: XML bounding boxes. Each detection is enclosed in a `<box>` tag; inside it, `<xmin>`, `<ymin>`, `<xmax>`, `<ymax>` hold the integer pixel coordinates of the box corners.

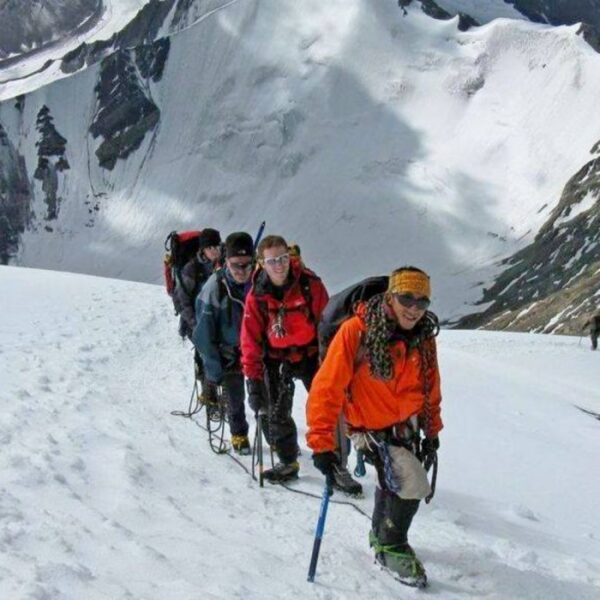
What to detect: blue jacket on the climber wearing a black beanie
<box><xmin>192</xmin><ymin>268</ymin><xmax>251</xmax><ymax>383</ymax></box>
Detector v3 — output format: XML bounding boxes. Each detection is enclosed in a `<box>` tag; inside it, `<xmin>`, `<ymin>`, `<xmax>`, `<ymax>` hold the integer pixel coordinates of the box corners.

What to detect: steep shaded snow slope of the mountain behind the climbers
<box><xmin>0</xmin><ymin>0</ymin><xmax>600</xmax><ymax>318</ymax></box>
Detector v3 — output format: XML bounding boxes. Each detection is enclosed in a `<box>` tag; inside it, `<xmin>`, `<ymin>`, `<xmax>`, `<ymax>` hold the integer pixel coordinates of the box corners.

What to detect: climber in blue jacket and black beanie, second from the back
<box><xmin>192</xmin><ymin>231</ymin><xmax>254</xmax><ymax>454</ymax></box>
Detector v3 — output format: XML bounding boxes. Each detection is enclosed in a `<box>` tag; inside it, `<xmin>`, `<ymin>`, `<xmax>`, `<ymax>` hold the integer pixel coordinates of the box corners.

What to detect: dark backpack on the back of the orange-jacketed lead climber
<box><xmin>318</xmin><ymin>275</ymin><xmax>389</xmax><ymax>361</ymax></box>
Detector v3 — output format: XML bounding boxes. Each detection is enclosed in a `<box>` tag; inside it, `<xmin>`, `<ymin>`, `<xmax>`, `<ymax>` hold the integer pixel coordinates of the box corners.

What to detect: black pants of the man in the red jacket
<box><xmin>261</xmin><ymin>354</ymin><xmax>319</xmax><ymax>463</ymax></box>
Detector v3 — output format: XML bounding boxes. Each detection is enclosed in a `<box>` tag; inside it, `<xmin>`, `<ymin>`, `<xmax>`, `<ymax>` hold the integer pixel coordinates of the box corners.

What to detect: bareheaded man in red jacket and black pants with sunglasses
<box><xmin>242</xmin><ymin>235</ymin><xmax>360</xmax><ymax>487</ymax></box>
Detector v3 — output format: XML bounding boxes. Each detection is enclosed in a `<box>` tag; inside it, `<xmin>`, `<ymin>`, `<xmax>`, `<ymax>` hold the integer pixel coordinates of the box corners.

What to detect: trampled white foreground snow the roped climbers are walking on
<box><xmin>0</xmin><ymin>267</ymin><xmax>600</xmax><ymax>600</ymax></box>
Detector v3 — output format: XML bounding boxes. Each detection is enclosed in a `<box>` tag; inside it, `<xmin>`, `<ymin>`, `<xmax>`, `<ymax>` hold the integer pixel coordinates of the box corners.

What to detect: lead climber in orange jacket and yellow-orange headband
<box><xmin>306</xmin><ymin>267</ymin><xmax>442</xmax><ymax>587</ymax></box>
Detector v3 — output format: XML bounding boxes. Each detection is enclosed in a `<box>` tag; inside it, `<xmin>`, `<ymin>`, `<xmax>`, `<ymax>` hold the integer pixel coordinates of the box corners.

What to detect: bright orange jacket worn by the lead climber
<box><xmin>306</xmin><ymin>316</ymin><xmax>443</xmax><ymax>452</ymax></box>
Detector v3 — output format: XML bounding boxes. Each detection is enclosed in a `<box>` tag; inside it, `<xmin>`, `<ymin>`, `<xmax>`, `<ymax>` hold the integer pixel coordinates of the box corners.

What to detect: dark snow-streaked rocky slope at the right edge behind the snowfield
<box><xmin>459</xmin><ymin>142</ymin><xmax>600</xmax><ymax>334</ymax></box>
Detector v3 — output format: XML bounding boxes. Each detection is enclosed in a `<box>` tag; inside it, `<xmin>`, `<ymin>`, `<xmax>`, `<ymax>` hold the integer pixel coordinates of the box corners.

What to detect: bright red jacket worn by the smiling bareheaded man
<box><xmin>241</xmin><ymin>259</ymin><xmax>329</xmax><ymax>379</ymax></box>
